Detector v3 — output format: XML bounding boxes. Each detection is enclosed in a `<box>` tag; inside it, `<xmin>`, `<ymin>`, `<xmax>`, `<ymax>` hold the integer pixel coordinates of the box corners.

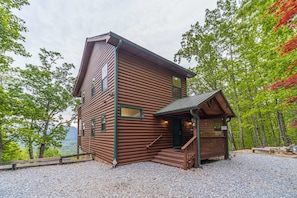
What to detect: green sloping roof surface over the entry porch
<box><xmin>154</xmin><ymin>90</ymin><xmax>221</xmax><ymax>116</ymax></box>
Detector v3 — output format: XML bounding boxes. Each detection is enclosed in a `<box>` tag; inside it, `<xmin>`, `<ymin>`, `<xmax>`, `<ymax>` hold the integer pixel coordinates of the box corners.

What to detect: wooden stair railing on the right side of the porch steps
<box><xmin>181</xmin><ymin>136</ymin><xmax>197</xmax><ymax>170</ymax></box>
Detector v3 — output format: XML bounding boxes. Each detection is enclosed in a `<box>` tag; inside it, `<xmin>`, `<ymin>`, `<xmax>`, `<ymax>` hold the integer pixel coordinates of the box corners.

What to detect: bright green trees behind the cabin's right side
<box><xmin>175</xmin><ymin>0</ymin><xmax>297</xmax><ymax>148</ymax></box>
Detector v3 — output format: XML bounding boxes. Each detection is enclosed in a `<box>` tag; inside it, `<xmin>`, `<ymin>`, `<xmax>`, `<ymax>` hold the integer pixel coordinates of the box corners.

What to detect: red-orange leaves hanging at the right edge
<box><xmin>269</xmin><ymin>0</ymin><xmax>297</xmax><ymax>127</ymax></box>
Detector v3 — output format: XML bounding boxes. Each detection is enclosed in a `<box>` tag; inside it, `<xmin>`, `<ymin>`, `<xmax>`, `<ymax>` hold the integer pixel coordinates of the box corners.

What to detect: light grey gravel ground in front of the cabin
<box><xmin>0</xmin><ymin>154</ymin><xmax>297</xmax><ymax>198</ymax></box>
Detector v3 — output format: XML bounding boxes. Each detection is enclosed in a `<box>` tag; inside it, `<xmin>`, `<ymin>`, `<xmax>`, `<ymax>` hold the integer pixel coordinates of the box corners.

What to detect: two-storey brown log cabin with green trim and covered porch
<box><xmin>73</xmin><ymin>32</ymin><xmax>235</xmax><ymax>169</ymax></box>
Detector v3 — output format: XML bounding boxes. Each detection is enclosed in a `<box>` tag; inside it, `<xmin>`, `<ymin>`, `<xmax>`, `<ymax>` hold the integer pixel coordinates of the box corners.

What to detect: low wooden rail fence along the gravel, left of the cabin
<box><xmin>1</xmin><ymin>153</ymin><xmax>95</xmax><ymax>170</ymax></box>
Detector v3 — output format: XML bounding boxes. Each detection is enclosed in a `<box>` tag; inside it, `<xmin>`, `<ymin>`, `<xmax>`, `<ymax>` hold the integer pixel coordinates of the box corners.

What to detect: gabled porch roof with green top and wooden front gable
<box><xmin>154</xmin><ymin>90</ymin><xmax>235</xmax><ymax>117</ymax></box>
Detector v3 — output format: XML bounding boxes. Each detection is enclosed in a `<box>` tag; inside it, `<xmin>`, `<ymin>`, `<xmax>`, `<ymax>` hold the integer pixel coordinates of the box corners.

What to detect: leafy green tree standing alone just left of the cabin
<box><xmin>19</xmin><ymin>49</ymin><xmax>75</xmax><ymax>158</ymax></box>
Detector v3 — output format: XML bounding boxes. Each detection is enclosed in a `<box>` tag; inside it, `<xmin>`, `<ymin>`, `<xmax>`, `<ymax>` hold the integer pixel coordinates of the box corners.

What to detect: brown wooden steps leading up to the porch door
<box><xmin>152</xmin><ymin>148</ymin><xmax>184</xmax><ymax>168</ymax></box>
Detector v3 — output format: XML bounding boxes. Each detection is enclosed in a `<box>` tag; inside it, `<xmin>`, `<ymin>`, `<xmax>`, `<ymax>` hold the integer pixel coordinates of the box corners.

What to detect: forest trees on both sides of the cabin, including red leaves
<box><xmin>0</xmin><ymin>0</ymin><xmax>297</xmax><ymax>161</ymax></box>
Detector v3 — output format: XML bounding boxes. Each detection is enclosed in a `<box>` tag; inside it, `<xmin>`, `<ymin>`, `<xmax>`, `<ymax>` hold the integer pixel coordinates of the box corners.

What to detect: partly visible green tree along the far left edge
<box><xmin>0</xmin><ymin>0</ymin><xmax>29</xmax><ymax>160</ymax></box>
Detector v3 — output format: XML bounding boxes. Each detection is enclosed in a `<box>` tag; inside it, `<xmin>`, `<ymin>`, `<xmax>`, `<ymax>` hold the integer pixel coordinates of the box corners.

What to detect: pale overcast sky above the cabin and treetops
<box><xmin>13</xmin><ymin>0</ymin><xmax>217</xmax><ymax>125</ymax></box>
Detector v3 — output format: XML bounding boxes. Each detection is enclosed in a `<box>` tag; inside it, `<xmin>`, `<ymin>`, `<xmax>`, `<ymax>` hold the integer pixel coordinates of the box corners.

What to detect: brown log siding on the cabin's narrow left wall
<box><xmin>81</xmin><ymin>42</ymin><xmax>114</xmax><ymax>163</ymax></box>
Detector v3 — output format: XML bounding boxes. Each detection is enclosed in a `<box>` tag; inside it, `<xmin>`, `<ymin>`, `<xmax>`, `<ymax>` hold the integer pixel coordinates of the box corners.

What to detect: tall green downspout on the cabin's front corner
<box><xmin>112</xmin><ymin>39</ymin><xmax>123</xmax><ymax>167</ymax></box>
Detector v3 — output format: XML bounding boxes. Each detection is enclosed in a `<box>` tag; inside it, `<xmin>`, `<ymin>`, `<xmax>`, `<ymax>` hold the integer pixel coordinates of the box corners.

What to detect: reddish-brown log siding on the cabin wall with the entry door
<box><xmin>118</xmin><ymin>51</ymin><xmax>186</xmax><ymax>164</ymax></box>
